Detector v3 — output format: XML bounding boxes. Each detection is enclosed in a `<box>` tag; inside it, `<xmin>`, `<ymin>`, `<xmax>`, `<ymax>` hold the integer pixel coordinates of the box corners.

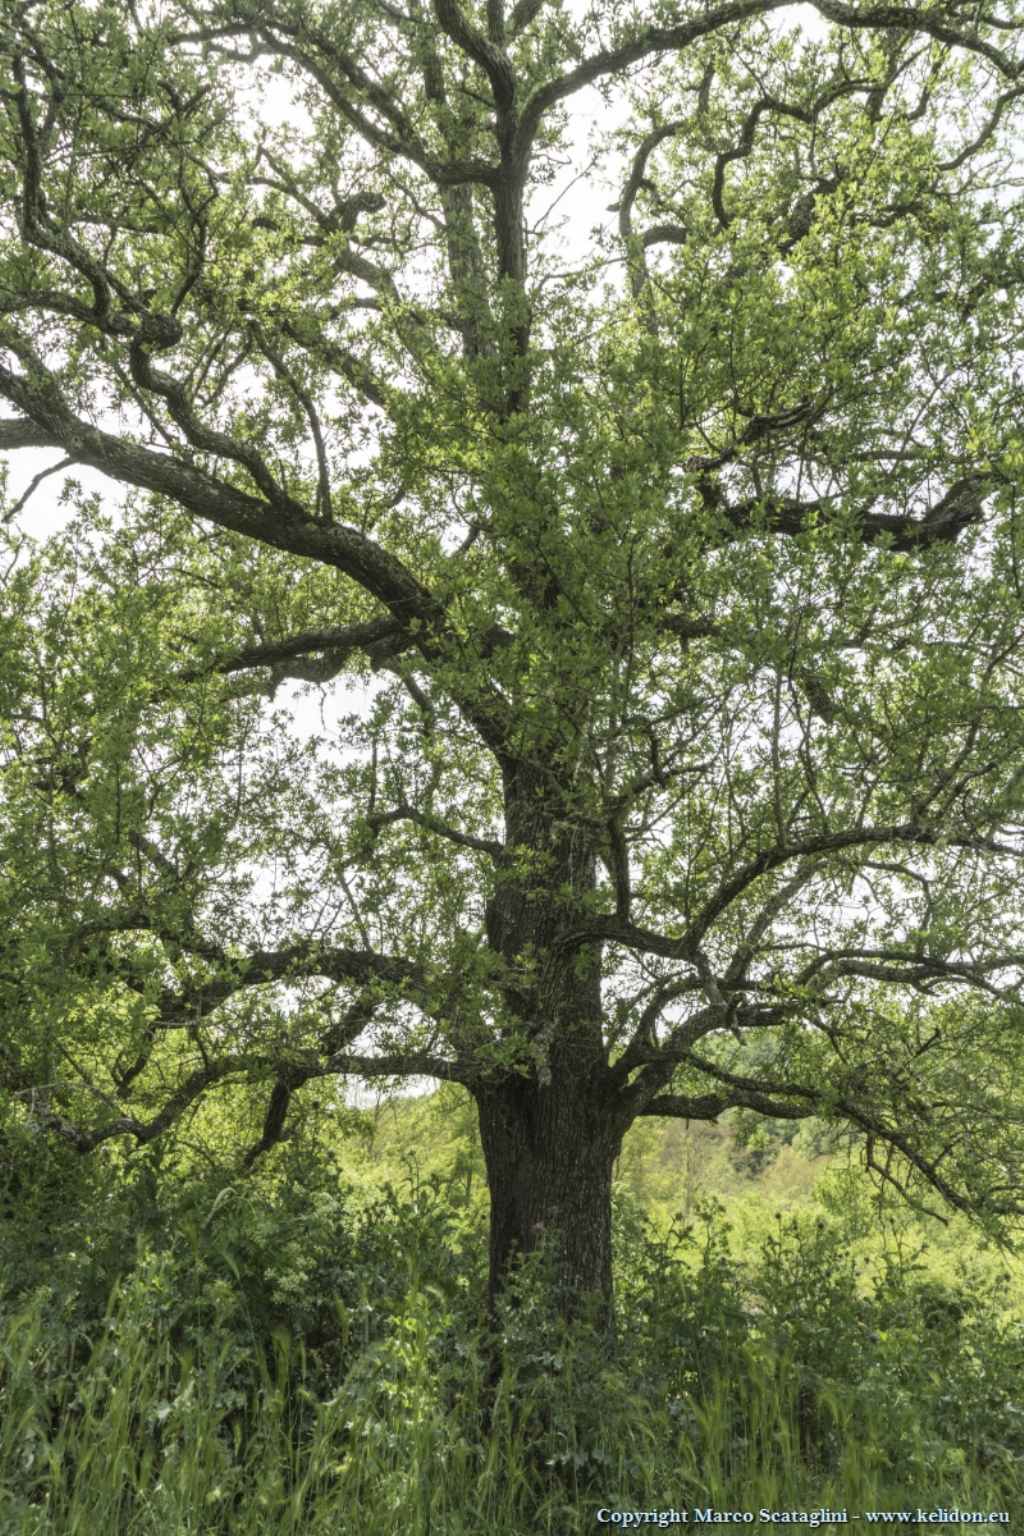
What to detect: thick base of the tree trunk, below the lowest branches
<box><xmin>476</xmin><ymin>1071</ymin><xmax>622</xmax><ymax>1327</ymax></box>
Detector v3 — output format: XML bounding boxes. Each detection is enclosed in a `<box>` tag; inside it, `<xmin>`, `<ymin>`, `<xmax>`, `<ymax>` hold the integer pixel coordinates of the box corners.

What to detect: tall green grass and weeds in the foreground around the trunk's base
<box><xmin>0</xmin><ymin>1207</ymin><xmax>1024</xmax><ymax>1536</ymax></box>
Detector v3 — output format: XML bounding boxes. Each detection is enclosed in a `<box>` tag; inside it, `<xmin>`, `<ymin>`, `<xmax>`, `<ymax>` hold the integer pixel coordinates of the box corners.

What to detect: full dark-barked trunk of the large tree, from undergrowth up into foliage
<box><xmin>473</xmin><ymin>765</ymin><xmax>625</xmax><ymax>1324</ymax></box>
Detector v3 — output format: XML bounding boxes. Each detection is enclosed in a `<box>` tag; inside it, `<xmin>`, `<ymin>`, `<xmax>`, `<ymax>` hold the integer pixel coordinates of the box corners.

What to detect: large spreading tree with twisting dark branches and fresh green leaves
<box><xmin>0</xmin><ymin>0</ymin><xmax>1024</xmax><ymax>1310</ymax></box>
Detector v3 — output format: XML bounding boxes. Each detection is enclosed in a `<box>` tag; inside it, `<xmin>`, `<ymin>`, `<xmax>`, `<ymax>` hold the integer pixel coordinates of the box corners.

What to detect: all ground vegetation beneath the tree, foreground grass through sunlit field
<box><xmin>0</xmin><ymin>1091</ymin><xmax>1024</xmax><ymax>1536</ymax></box>
